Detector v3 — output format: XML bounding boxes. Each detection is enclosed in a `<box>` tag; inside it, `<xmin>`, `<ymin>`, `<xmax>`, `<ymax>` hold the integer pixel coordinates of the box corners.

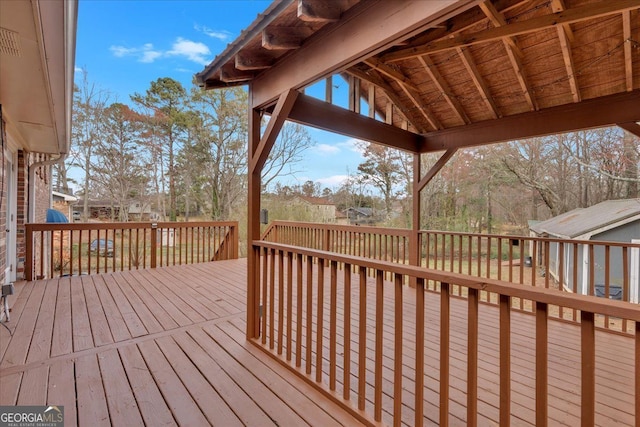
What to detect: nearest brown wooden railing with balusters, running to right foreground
<box><xmin>247</xmin><ymin>241</ymin><xmax>640</xmax><ymax>426</ymax></box>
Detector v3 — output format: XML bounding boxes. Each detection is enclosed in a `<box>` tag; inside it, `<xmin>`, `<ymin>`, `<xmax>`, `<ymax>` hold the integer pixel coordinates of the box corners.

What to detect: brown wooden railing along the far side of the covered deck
<box><xmin>264</xmin><ymin>221</ymin><xmax>640</xmax><ymax>333</ymax></box>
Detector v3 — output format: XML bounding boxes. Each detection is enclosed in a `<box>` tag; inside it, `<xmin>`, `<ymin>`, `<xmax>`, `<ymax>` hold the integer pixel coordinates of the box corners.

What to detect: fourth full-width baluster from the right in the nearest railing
<box><xmin>467</xmin><ymin>288</ymin><xmax>478</xmax><ymax>426</ymax></box>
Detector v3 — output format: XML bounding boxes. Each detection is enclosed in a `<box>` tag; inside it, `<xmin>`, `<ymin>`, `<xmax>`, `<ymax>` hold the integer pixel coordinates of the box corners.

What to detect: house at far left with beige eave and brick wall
<box><xmin>0</xmin><ymin>0</ymin><xmax>77</xmax><ymax>284</ymax></box>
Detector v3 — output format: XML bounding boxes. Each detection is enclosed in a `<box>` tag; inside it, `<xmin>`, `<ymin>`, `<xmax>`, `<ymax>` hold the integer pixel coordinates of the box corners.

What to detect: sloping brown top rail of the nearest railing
<box><xmin>253</xmin><ymin>241</ymin><xmax>640</xmax><ymax>322</ymax></box>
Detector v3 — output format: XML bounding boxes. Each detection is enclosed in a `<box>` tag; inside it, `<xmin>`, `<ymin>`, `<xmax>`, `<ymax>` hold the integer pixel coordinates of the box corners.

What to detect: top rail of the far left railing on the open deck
<box><xmin>26</xmin><ymin>221</ymin><xmax>238</xmax><ymax>231</ymax></box>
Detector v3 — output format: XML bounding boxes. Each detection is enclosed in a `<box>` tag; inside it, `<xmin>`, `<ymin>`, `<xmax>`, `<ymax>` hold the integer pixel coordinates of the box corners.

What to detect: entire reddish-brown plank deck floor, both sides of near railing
<box><xmin>0</xmin><ymin>259</ymin><xmax>634</xmax><ymax>426</ymax></box>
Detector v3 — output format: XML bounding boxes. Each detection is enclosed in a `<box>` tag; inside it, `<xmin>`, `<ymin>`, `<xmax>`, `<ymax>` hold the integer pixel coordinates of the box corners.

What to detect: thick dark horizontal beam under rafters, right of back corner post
<box><xmin>421</xmin><ymin>90</ymin><xmax>640</xmax><ymax>153</ymax></box>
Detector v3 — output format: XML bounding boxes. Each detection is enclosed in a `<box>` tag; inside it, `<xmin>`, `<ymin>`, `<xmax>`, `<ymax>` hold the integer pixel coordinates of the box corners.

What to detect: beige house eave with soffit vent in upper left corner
<box><xmin>0</xmin><ymin>0</ymin><xmax>78</xmax><ymax>154</ymax></box>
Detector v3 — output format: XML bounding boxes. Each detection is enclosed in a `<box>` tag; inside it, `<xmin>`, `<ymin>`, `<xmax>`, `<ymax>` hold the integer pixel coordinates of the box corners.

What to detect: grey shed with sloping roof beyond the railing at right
<box><xmin>530</xmin><ymin>199</ymin><xmax>640</xmax><ymax>302</ymax></box>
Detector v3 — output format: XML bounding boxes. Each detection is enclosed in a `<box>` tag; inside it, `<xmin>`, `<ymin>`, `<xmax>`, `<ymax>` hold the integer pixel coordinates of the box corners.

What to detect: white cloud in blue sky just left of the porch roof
<box><xmin>109</xmin><ymin>37</ymin><xmax>211</xmax><ymax>65</ymax></box>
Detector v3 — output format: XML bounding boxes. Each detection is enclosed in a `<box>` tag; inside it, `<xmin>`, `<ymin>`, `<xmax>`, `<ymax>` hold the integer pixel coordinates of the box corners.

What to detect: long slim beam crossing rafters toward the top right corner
<box><xmin>380</xmin><ymin>0</ymin><xmax>640</xmax><ymax>62</ymax></box>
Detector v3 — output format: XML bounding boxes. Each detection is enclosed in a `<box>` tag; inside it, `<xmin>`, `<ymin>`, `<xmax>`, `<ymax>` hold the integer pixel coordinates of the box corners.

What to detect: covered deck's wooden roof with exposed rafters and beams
<box><xmin>197</xmin><ymin>0</ymin><xmax>640</xmax><ymax>153</ymax></box>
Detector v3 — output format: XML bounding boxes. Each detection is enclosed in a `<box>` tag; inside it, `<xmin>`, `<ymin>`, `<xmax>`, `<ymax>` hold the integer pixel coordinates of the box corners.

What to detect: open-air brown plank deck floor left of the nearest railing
<box><xmin>0</xmin><ymin>259</ymin><xmax>359</xmax><ymax>426</ymax></box>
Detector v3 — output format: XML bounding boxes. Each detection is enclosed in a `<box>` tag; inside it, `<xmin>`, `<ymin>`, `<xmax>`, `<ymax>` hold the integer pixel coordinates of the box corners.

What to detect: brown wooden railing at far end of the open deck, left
<box><xmin>25</xmin><ymin>221</ymin><xmax>238</xmax><ymax>280</ymax></box>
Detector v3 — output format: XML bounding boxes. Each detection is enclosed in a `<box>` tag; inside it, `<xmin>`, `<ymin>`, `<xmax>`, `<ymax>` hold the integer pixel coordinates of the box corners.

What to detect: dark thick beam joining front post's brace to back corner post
<box><xmin>276</xmin><ymin>95</ymin><xmax>425</xmax><ymax>153</ymax></box>
